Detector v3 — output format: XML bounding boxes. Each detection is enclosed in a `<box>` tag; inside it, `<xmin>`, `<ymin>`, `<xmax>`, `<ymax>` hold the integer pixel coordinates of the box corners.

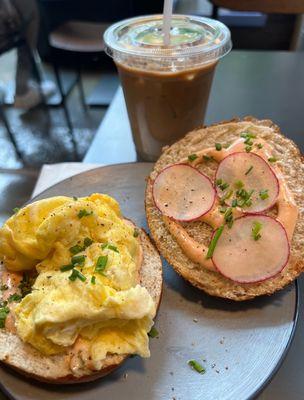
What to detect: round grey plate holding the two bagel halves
<box><xmin>0</xmin><ymin>163</ymin><xmax>296</xmax><ymax>400</ymax></box>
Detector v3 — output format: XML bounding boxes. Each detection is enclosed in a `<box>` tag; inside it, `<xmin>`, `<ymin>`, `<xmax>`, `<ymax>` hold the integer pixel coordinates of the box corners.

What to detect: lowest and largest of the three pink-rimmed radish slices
<box><xmin>212</xmin><ymin>215</ymin><xmax>290</xmax><ymax>283</ymax></box>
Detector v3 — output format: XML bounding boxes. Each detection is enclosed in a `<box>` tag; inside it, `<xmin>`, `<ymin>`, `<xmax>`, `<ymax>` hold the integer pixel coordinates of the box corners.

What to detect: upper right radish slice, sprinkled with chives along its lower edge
<box><xmin>215</xmin><ymin>152</ymin><xmax>280</xmax><ymax>213</ymax></box>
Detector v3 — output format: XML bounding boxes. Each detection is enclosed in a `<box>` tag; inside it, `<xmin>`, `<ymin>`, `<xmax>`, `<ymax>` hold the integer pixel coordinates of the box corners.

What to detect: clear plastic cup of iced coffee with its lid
<box><xmin>104</xmin><ymin>15</ymin><xmax>232</xmax><ymax>161</ymax></box>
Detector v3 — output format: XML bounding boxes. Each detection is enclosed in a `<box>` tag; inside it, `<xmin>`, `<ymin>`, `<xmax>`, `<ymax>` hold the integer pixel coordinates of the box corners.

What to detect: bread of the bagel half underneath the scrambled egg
<box><xmin>0</xmin><ymin>230</ymin><xmax>162</xmax><ymax>384</ymax></box>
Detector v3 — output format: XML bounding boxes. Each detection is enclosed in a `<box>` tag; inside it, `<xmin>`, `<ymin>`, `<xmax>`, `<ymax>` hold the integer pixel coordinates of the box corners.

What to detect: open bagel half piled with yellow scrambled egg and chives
<box><xmin>0</xmin><ymin>194</ymin><xmax>162</xmax><ymax>383</ymax></box>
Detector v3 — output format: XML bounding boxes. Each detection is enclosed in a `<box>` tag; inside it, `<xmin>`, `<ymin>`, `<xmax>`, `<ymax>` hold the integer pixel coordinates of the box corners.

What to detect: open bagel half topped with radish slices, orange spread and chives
<box><xmin>146</xmin><ymin>117</ymin><xmax>304</xmax><ymax>301</ymax></box>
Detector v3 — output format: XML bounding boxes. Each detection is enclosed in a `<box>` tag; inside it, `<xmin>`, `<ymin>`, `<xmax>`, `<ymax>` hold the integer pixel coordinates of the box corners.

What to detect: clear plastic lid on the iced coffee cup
<box><xmin>104</xmin><ymin>15</ymin><xmax>232</xmax><ymax>63</ymax></box>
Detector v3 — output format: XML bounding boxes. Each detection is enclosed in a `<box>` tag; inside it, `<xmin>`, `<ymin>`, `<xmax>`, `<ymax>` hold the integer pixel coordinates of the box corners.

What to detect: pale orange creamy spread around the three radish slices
<box><xmin>162</xmin><ymin>135</ymin><xmax>298</xmax><ymax>271</ymax></box>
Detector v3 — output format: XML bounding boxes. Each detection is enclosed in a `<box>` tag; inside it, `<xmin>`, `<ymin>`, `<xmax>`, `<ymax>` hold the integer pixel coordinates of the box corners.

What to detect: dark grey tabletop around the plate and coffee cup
<box><xmin>84</xmin><ymin>51</ymin><xmax>304</xmax><ymax>400</ymax></box>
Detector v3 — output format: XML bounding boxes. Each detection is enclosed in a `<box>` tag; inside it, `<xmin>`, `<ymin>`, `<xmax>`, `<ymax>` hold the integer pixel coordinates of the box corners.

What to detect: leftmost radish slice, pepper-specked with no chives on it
<box><xmin>153</xmin><ymin>164</ymin><xmax>216</xmax><ymax>221</ymax></box>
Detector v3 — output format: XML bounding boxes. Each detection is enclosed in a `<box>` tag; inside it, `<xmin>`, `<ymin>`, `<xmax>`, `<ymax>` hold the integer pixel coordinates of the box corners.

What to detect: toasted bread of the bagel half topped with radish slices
<box><xmin>145</xmin><ymin>117</ymin><xmax>304</xmax><ymax>301</ymax></box>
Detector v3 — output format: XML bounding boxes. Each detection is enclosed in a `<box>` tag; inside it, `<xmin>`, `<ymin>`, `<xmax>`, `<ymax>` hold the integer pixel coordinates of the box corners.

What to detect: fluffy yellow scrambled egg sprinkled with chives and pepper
<box><xmin>0</xmin><ymin>194</ymin><xmax>156</xmax><ymax>368</ymax></box>
